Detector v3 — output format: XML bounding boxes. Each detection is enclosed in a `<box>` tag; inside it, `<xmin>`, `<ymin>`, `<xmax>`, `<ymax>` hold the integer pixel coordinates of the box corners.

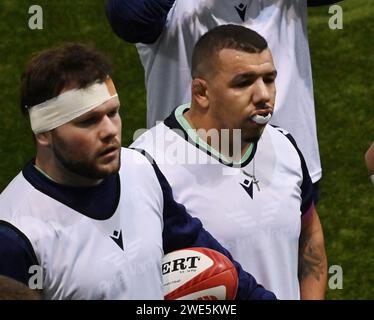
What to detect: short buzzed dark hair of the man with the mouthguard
<box><xmin>191</xmin><ymin>24</ymin><xmax>268</xmax><ymax>78</ymax></box>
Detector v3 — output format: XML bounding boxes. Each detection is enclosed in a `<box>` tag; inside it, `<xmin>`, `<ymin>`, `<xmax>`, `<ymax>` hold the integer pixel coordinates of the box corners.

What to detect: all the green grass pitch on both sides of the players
<box><xmin>0</xmin><ymin>0</ymin><xmax>374</xmax><ymax>299</ymax></box>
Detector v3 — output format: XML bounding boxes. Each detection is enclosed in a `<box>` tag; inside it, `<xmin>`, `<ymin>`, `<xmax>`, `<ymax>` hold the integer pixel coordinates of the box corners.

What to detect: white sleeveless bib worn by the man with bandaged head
<box><xmin>0</xmin><ymin>149</ymin><xmax>163</xmax><ymax>300</ymax></box>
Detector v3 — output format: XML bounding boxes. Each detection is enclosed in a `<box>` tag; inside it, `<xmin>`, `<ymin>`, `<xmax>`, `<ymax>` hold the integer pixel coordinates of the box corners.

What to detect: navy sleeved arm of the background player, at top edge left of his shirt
<box><xmin>106</xmin><ymin>0</ymin><xmax>175</xmax><ymax>43</ymax></box>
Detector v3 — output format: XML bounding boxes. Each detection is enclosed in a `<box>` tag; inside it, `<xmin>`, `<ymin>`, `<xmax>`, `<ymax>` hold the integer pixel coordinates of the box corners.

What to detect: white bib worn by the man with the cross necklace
<box><xmin>132</xmin><ymin>106</ymin><xmax>312</xmax><ymax>299</ymax></box>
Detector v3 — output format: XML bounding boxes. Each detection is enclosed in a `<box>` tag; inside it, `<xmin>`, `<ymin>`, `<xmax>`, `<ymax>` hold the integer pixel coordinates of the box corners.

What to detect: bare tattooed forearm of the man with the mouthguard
<box><xmin>299</xmin><ymin>212</ymin><xmax>327</xmax><ymax>300</ymax></box>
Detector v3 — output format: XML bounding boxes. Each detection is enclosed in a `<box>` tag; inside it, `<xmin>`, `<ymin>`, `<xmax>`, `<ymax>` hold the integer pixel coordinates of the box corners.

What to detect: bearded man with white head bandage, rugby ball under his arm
<box><xmin>0</xmin><ymin>44</ymin><xmax>274</xmax><ymax>299</ymax></box>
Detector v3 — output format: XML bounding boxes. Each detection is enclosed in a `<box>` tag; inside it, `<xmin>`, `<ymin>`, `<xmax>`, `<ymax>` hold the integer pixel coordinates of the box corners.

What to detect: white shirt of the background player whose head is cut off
<box><xmin>137</xmin><ymin>0</ymin><xmax>322</xmax><ymax>182</ymax></box>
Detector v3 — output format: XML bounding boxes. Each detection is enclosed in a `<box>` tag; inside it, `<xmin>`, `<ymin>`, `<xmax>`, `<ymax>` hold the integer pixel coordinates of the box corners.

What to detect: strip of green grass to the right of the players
<box><xmin>309</xmin><ymin>0</ymin><xmax>374</xmax><ymax>299</ymax></box>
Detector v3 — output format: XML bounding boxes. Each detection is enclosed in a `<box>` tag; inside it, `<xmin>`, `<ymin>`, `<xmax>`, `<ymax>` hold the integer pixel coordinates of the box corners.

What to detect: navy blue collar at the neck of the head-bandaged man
<box><xmin>22</xmin><ymin>160</ymin><xmax>121</xmax><ymax>220</ymax></box>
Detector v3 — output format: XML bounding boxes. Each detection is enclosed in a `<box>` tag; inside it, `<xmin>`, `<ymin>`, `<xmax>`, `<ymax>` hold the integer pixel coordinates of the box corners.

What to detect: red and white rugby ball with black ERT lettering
<box><xmin>162</xmin><ymin>248</ymin><xmax>238</xmax><ymax>300</ymax></box>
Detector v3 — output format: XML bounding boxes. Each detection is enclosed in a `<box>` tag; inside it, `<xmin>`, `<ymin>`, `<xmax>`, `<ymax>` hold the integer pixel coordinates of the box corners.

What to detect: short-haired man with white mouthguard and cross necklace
<box><xmin>133</xmin><ymin>25</ymin><xmax>327</xmax><ymax>299</ymax></box>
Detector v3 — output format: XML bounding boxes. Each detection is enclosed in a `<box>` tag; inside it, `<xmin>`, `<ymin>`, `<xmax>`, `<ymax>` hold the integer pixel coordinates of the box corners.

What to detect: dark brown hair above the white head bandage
<box><xmin>21</xmin><ymin>43</ymin><xmax>111</xmax><ymax>113</ymax></box>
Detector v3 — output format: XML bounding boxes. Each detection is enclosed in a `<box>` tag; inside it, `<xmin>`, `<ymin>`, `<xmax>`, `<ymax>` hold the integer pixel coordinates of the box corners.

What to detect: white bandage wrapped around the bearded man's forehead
<box><xmin>28</xmin><ymin>78</ymin><xmax>118</xmax><ymax>134</ymax></box>
